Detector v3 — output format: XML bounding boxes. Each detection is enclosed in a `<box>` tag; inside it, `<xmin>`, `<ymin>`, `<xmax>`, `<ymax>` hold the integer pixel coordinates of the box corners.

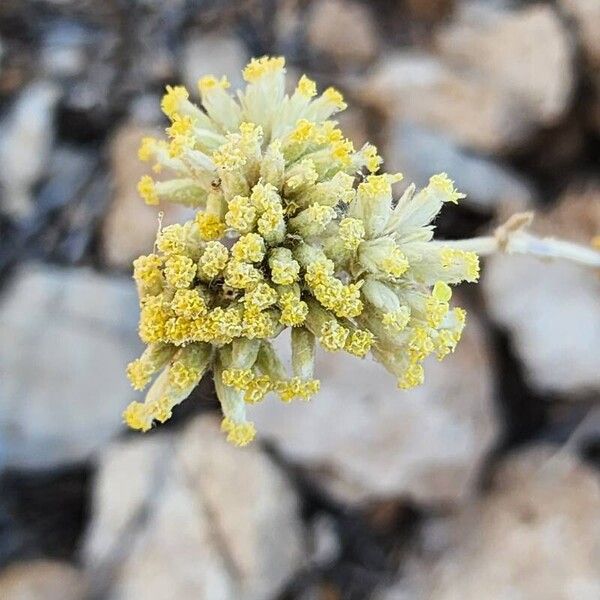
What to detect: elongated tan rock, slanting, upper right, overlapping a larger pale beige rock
<box><xmin>356</xmin><ymin>50</ymin><xmax>532</xmax><ymax>152</ymax></box>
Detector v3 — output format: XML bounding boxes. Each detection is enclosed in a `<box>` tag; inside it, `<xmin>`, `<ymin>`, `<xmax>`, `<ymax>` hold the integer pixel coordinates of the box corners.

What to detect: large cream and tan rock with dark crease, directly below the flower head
<box><xmin>84</xmin><ymin>416</ymin><xmax>305</xmax><ymax>600</ymax></box>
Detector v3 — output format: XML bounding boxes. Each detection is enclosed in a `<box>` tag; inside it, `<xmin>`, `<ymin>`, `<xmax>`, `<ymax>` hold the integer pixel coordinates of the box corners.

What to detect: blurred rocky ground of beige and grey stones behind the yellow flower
<box><xmin>0</xmin><ymin>0</ymin><xmax>600</xmax><ymax>600</ymax></box>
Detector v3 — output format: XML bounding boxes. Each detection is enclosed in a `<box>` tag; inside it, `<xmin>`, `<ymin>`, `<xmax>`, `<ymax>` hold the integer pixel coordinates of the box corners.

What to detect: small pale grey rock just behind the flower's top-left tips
<box><xmin>182</xmin><ymin>33</ymin><xmax>249</xmax><ymax>95</ymax></box>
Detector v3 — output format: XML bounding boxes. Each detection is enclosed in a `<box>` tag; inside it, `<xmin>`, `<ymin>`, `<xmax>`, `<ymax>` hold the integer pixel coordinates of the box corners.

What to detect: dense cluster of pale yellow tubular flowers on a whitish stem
<box><xmin>124</xmin><ymin>57</ymin><xmax>479</xmax><ymax>445</ymax></box>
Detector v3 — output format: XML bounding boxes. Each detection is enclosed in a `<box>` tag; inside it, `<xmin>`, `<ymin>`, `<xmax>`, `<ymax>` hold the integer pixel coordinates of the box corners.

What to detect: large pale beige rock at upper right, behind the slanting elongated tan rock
<box><xmin>437</xmin><ymin>2</ymin><xmax>575</xmax><ymax>125</ymax></box>
